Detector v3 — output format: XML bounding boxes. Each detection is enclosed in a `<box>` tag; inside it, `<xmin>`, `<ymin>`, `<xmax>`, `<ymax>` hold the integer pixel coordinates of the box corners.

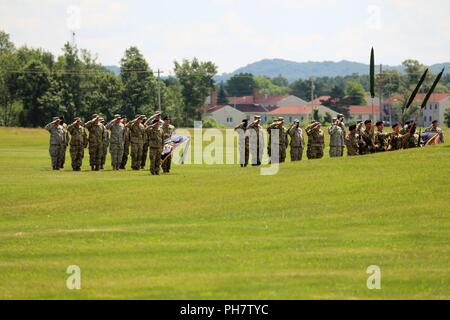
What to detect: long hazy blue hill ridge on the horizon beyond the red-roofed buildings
<box><xmin>216</xmin><ymin>59</ymin><xmax>450</xmax><ymax>82</ymax></box>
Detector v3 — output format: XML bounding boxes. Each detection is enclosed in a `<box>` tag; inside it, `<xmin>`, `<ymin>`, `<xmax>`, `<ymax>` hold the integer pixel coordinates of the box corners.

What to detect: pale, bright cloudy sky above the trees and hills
<box><xmin>0</xmin><ymin>0</ymin><xmax>450</xmax><ymax>74</ymax></box>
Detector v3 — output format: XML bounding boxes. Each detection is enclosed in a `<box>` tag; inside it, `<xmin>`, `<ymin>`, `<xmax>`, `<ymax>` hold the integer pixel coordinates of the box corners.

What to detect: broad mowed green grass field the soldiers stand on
<box><xmin>0</xmin><ymin>128</ymin><xmax>450</xmax><ymax>299</ymax></box>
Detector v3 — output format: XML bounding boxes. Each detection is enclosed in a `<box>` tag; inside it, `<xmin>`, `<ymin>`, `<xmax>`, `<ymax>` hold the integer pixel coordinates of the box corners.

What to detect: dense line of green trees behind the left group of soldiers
<box><xmin>0</xmin><ymin>31</ymin><xmax>217</xmax><ymax>127</ymax></box>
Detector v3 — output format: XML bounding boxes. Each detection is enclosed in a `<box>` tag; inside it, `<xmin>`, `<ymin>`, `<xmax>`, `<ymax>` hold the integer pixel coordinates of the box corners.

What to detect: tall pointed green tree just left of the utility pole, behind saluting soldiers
<box><xmin>120</xmin><ymin>47</ymin><xmax>156</xmax><ymax>118</ymax></box>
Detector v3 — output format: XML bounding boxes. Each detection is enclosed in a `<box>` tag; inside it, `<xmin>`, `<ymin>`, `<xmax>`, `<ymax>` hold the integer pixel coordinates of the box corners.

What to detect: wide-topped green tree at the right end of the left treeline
<box><xmin>175</xmin><ymin>58</ymin><xmax>217</xmax><ymax>126</ymax></box>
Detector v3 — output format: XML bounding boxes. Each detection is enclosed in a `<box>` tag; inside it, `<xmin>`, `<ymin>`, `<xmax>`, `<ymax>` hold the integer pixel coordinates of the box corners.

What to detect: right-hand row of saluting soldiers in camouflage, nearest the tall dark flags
<box><xmin>235</xmin><ymin>114</ymin><xmax>443</xmax><ymax>167</ymax></box>
